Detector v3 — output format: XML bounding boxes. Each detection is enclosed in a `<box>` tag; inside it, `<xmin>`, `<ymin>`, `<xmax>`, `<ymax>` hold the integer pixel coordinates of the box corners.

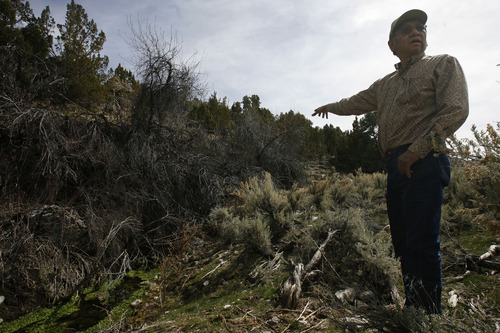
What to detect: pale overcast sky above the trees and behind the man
<box><xmin>29</xmin><ymin>0</ymin><xmax>500</xmax><ymax>137</ymax></box>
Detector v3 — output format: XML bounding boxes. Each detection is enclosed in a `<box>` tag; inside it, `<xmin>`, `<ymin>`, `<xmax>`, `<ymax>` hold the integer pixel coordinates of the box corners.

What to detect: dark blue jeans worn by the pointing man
<box><xmin>386</xmin><ymin>145</ymin><xmax>451</xmax><ymax>313</ymax></box>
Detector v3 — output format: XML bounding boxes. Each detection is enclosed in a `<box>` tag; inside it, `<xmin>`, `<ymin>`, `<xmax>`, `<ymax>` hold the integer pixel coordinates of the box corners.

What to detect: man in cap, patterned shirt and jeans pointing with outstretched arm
<box><xmin>313</xmin><ymin>9</ymin><xmax>469</xmax><ymax>314</ymax></box>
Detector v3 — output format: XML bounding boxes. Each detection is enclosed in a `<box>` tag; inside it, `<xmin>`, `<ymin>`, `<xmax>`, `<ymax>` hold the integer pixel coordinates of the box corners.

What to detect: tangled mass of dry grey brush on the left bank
<box><xmin>0</xmin><ymin>102</ymin><xmax>247</xmax><ymax>320</ymax></box>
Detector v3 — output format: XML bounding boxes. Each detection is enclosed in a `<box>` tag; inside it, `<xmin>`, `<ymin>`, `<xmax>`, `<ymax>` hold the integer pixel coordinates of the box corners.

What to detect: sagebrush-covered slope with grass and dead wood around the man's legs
<box><xmin>0</xmin><ymin>144</ymin><xmax>499</xmax><ymax>332</ymax></box>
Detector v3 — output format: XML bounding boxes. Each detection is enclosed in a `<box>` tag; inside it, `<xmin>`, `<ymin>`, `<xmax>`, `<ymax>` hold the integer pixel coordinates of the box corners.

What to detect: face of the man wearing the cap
<box><xmin>389</xmin><ymin>20</ymin><xmax>427</xmax><ymax>59</ymax></box>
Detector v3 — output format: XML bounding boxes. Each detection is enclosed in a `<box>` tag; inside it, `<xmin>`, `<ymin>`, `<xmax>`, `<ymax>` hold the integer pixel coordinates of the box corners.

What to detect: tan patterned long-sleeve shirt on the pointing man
<box><xmin>326</xmin><ymin>53</ymin><xmax>469</xmax><ymax>158</ymax></box>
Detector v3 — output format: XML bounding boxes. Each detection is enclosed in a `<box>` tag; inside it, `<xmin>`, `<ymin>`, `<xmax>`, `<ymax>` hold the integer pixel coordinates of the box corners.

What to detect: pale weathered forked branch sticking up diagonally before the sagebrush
<box><xmin>281</xmin><ymin>230</ymin><xmax>337</xmax><ymax>309</ymax></box>
